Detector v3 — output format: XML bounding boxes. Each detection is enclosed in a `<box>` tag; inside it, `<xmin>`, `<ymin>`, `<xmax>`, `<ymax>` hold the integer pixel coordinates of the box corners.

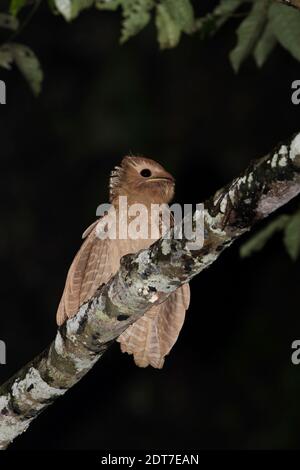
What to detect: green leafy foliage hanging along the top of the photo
<box><xmin>0</xmin><ymin>0</ymin><xmax>300</xmax><ymax>94</ymax></box>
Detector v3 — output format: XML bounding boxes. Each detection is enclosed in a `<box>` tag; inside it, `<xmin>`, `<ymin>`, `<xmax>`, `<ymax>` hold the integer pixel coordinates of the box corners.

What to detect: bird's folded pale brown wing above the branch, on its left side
<box><xmin>56</xmin><ymin>221</ymin><xmax>118</xmax><ymax>325</ymax></box>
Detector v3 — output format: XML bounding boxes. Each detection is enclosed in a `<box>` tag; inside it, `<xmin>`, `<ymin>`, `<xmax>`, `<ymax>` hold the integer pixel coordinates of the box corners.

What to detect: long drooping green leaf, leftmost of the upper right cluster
<box><xmin>230</xmin><ymin>0</ymin><xmax>270</xmax><ymax>72</ymax></box>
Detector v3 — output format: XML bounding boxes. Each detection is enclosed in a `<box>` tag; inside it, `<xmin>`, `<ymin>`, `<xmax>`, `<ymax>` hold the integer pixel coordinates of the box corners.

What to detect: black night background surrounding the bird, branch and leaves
<box><xmin>0</xmin><ymin>2</ymin><xmax>300</xmax><ymax>450</ymax></box>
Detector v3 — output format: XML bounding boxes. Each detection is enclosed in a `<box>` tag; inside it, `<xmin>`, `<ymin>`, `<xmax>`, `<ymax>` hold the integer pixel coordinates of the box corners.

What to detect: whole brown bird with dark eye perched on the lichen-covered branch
<box><xmin>57</xmin><ymin>156</ymin><xmax>190</xmax><ymax>368</ymax></box>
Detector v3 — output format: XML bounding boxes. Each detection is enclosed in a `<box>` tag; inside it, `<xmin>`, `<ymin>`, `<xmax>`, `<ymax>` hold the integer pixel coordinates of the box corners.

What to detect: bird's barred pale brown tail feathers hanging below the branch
<box><xmin>117</xmin><ymin>284</ymin><xmax>190</xmax><ymax>369</ymax></box>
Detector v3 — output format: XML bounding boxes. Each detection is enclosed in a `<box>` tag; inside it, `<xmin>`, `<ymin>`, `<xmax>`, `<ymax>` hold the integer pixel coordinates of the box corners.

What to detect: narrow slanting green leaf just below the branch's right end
<box><xmin>240</xmin><ymin>215</ymin><xmax>290</xmax><ymax>258</ymax></box>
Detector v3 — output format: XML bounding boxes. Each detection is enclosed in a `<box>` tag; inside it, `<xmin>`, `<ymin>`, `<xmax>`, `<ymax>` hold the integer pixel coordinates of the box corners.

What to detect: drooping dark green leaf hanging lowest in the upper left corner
<box><xmin>7</xmin><ymin>43</ymin><xmax>43</xmax><ymax>95</ymax></box>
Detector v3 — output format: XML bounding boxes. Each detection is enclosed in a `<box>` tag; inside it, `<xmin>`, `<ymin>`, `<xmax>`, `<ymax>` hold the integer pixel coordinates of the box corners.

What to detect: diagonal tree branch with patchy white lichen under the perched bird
<box><xmin>0</xmin><ymin>133</ymin><xmax>300</xmax><ymax>449</ymax></box>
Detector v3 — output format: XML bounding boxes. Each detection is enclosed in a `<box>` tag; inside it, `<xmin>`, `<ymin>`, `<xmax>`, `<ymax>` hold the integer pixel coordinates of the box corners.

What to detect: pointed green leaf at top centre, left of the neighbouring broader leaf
<box><xmin>121</xmin><ymin>0</ymin><xmax>154</xmax><ymax>43</ymax></box>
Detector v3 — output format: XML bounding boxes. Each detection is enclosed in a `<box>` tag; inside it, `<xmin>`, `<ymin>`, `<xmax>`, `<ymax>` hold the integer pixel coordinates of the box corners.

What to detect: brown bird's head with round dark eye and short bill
<box><xmin>110</xmin><ymin>156</ymin><xmax>175</xmax><ymax>204</ymax></box>
